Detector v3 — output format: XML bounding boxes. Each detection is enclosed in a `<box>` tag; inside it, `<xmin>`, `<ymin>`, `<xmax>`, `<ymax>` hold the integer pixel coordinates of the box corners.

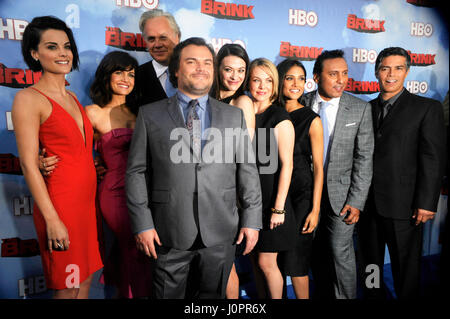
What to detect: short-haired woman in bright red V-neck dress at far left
<box><xmin>12</xmin><ymin>16</ymin><xmax>103</xmax><ymax>299</ymax></box>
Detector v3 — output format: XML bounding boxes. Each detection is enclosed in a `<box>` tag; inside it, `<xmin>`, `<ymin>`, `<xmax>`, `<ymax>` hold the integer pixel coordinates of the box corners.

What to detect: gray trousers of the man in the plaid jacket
<box><xmin>312</xmin><ymin>192</ymin><xmax>357</xmax><ymax>299</ymax></box>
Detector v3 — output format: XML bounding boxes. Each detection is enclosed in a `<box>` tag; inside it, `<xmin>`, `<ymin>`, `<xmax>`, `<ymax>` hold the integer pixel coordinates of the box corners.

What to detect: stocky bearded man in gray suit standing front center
<box><xmin>126</xmin><ymin>38</ymin><xmax>262</xmax><ymax>298</ymax></box>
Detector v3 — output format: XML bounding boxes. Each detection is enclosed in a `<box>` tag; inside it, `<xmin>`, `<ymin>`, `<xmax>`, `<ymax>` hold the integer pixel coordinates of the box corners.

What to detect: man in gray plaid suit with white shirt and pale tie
<box><xmin>302</xmin><ymin>50</ymin><xmax>374</xmax><ymax>299</ymax></box>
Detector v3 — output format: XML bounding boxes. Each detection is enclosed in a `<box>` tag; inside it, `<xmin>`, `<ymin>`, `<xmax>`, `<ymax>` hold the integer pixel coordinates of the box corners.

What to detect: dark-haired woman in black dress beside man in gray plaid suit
<box><xmin>277</xmin><ymin>59</ymin><xmax>323</xmax><ymax>299</ymax></box>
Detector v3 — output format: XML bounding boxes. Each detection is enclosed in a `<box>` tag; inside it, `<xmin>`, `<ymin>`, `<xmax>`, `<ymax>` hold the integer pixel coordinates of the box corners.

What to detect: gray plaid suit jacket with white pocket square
<box><xmin>302</xmin><ymin>91</ymin><xmax>374</xmax><ymax>214</ymax></box>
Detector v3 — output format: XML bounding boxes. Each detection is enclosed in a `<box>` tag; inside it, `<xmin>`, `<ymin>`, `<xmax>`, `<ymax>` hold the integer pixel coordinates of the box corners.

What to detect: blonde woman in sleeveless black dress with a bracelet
<box><xmin>238</xmin><ymin>58</ymin><xmax>296</xmax><ymax>299</ymax></box>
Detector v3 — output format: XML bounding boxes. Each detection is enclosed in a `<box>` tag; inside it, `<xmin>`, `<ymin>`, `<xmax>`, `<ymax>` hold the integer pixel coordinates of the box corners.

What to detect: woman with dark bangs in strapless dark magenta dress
<box><xmin>84</xmin><ymin>51</ymin><xmax>151</xmax><ymax>298</ymax></box>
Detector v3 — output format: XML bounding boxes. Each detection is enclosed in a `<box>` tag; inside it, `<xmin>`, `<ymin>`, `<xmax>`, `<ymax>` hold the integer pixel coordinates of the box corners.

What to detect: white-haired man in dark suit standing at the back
<box><xmin>136</xmin><ymin>9</ymin><xmax>181</xmax><ymax>106</ymax></box>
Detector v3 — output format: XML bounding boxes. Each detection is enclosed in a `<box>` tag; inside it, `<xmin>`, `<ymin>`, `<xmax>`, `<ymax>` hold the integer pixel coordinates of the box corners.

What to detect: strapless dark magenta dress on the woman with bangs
<box><xmin>96</xmin><ymin>128</ymin><xmax>151</xmax><ymax>298</ymax></box>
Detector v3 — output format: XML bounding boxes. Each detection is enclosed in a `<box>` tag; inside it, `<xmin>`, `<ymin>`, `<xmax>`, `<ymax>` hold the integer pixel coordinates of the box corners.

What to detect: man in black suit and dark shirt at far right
<box><xmin>358</xmin><ymin>47</ymin><xmax>445</xmax><ymax>299</ymax></box>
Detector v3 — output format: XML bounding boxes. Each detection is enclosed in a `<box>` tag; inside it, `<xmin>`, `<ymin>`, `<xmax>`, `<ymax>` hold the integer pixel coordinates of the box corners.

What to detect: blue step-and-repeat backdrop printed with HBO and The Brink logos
<box><xmin>0</xmin><ymin>0</ymin><xmax>449</xmax><ymax>298</ymax></box>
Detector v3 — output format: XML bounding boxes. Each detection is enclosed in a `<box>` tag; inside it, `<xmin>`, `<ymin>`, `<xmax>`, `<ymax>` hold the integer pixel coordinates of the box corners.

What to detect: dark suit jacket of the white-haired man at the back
<box><xmin>136</xmin><ymin>61</ymin><xmax>167</xmax><ymax>106</ymax></box>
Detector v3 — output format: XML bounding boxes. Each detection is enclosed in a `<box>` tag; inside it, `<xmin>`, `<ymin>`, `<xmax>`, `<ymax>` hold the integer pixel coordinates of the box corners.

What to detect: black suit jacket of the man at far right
<box><xmin>370</xmin><ymin>89</ymin><xmax>446</xmax><ymax>219</ymax></box>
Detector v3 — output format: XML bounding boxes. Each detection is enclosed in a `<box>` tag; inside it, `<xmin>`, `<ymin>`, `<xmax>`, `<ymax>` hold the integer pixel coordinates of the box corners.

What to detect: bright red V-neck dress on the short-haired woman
<box><xmin>33</xmin><ymin>89</ymin><xmax>103</xmax><ymax>289</ymax></box>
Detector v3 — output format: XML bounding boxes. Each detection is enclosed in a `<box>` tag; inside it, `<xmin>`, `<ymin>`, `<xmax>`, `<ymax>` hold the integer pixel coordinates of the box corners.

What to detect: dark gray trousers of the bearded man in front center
<box><xmin>153</xmin><ymin>239</ymin><xmax>236</xmax><ymax>299</ymax></box>
